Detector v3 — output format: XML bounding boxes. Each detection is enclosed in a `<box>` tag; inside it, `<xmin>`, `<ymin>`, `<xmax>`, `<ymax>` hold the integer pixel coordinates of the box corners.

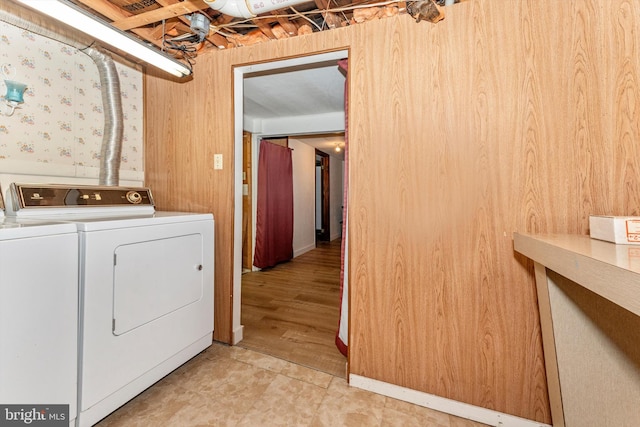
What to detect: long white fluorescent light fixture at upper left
<box><xmin>17</xmin><ymin>0</ymin><xmax>191</xmax><ymax>77</ymax></box>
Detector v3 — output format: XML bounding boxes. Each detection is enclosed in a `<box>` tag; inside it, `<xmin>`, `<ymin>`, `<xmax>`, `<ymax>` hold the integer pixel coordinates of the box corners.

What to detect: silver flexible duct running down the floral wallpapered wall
<box><xmin>0</xmin><ymin>4</ymin><xmax>123</xmax><ymax>186</ymax></box>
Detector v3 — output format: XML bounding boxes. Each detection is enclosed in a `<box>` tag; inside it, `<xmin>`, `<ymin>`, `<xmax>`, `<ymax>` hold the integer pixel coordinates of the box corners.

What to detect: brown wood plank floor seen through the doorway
<box><xmin>238</xmin><ymin>239</ymin><xmax>346</xmax><ymax>378</ymax></box>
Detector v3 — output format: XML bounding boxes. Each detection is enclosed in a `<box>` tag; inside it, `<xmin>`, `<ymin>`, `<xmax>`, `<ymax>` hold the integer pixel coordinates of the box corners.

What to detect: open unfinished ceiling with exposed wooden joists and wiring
<box><xmin>14</xmin><ymin>0</ymin><xmax>456</xmax><ymax>64</ymax></box>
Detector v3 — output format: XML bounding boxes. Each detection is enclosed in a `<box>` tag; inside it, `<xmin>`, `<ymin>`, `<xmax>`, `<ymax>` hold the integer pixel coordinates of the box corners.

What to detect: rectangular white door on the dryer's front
<box><xmin>113</xmin><ymin>234</ymin><xmax>203</xmax><ymax>335</ymax></box>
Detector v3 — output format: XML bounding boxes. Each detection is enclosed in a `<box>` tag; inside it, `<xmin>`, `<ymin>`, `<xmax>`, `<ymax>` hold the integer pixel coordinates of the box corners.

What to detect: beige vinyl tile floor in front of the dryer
<box><xmin>97</xmin><ymin>343</ymin><xmax>484</xmax><ymax>427</ymax></box>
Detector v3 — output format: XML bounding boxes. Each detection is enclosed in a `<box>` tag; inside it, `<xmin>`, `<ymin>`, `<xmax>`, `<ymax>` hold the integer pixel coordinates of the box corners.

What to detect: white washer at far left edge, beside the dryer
<box><xmin>0</xmin><ymin>189</ymin><xmax>78</xmax><ymax>425</ymax></box>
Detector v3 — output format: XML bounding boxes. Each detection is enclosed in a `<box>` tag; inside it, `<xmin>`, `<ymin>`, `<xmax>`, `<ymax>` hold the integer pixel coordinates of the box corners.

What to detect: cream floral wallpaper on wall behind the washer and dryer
<box><xmin>0</xmin><ymin>21</ymin><xmax>144</xmax><ymax>180</ymax></box>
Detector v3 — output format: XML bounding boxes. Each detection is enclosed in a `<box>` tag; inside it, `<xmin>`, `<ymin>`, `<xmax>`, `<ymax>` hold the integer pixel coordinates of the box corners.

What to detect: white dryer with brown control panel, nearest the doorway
<box><xmin>12</xmin><ymin>184</ymin><xmax>214</xmax><ymax>426</ymax></box>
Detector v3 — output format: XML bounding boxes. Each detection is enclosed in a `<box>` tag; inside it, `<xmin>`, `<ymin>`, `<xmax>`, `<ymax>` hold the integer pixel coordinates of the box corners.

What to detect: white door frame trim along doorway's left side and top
<box><xmin>231</xmin><ymin>49</ymin><xmax>349</xmax><ymax>345</ymax></box>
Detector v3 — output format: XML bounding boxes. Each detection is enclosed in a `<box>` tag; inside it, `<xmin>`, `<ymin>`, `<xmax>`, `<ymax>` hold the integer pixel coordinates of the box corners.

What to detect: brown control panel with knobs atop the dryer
<box><xmin>11</xmin><ymin>183</ymin><xmax>154</xmax><ymax>211</ymax></box>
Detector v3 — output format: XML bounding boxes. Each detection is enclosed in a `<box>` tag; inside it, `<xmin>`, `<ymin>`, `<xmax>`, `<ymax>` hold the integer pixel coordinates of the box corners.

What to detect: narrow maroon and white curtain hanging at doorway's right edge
<box><xmin>336</xmin><ymin>59</ymin><xmax>349</xmax><ymax>356</ymax></box>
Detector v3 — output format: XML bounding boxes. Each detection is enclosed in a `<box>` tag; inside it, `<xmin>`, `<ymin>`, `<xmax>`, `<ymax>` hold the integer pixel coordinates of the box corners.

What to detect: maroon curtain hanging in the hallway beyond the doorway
<box><xmin>253</xmin><ymin>140</ymin><xmax>293</xmax><ymax>268</ymax></box>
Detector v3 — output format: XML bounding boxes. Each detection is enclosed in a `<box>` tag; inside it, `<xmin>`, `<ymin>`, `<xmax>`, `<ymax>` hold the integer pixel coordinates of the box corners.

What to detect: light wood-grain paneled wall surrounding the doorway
<box><xmin>146</xmin><ymin>0</ymin><xmax>640</xmax><ymax>423</ymax></box>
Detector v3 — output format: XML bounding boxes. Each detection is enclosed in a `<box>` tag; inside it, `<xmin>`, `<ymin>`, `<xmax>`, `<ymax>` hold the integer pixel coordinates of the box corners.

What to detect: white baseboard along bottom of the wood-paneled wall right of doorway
<box><xmin>349</xmin><ymin>374</ymin><xmax>551</xmax><ymax>427</ymax></box>
